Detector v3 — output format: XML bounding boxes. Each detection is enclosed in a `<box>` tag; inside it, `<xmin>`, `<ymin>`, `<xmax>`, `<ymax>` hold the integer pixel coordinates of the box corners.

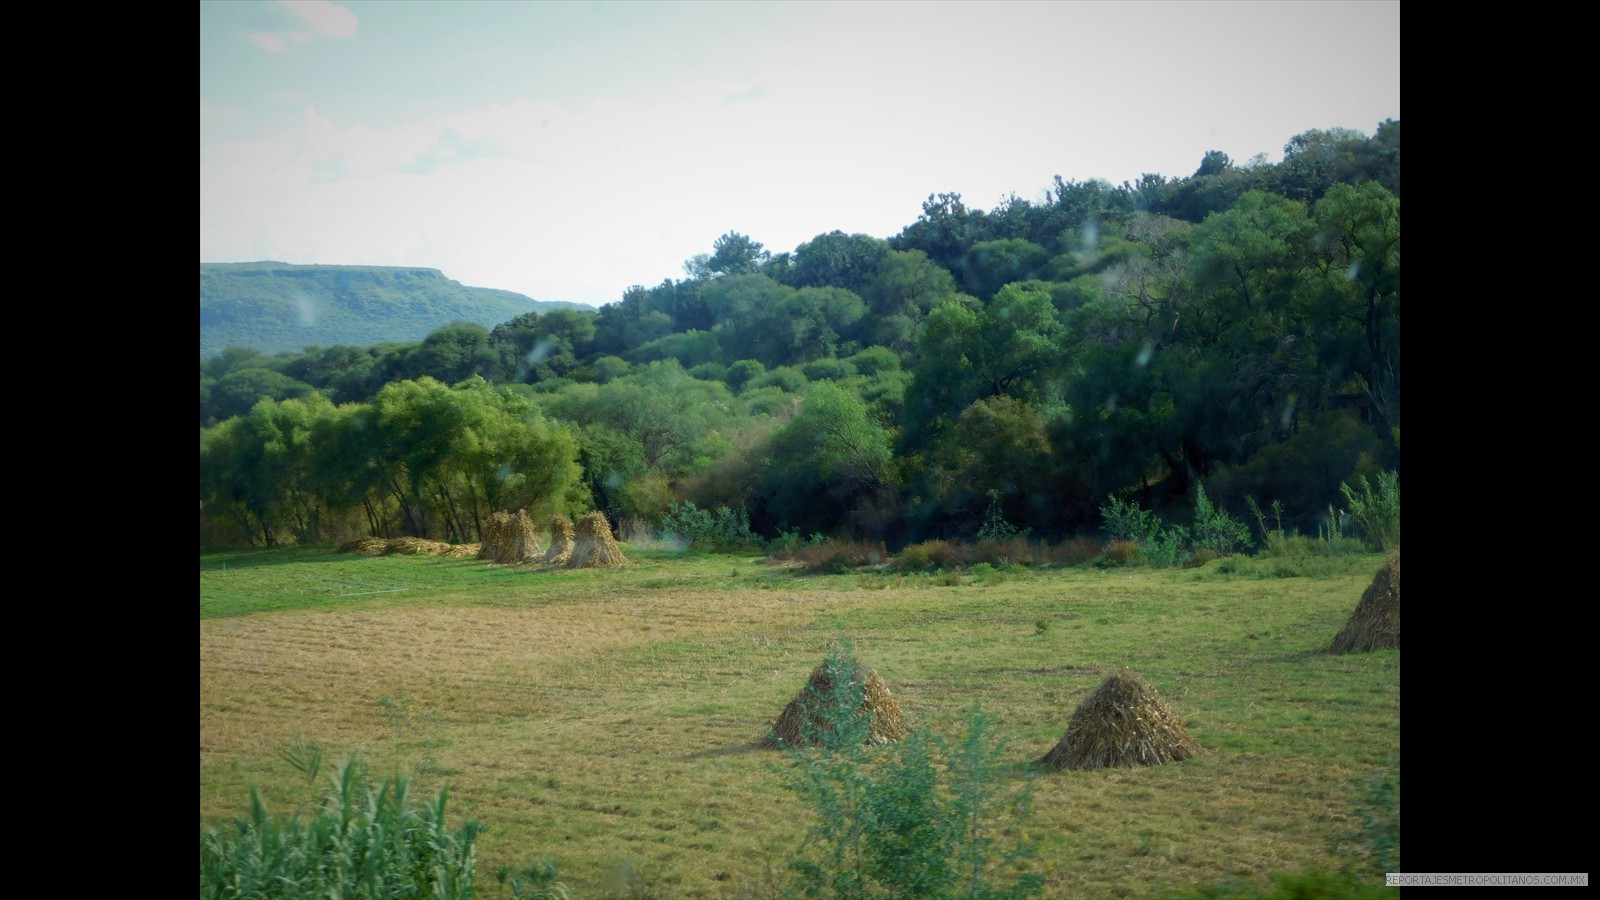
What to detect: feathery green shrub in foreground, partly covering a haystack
<box><xmin>789</xmin><ymin>701</ymin><xmax>1043</xmax><ymax>898</ymax></box>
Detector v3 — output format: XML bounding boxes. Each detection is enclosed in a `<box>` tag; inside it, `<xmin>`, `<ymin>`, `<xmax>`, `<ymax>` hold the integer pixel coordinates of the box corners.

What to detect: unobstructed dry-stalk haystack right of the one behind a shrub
<box><xmin>1040</xmin><ymin>669</ymin><xmax>1200</xmax><ymax>769</ymax></box>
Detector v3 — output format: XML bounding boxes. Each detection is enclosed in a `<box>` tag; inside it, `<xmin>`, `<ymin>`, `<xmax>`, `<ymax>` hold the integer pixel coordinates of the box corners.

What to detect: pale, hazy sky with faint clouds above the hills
<box><xmin>200</xmin><ymin>0</ymin><xmax>1400</xmax><ymax>306</ymax></box>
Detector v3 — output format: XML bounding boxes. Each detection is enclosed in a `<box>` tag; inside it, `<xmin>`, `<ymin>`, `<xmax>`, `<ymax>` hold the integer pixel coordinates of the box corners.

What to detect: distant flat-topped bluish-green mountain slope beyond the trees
<box><xmin>200</xmin><ymin>263</ymin><xmax>592</xmax><ymax>359</ymax></box>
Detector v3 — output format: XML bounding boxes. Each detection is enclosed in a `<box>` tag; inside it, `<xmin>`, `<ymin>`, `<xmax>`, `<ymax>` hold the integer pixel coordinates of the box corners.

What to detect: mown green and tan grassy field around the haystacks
<box><xmin>200</xmin><ymin>549</ymin><xmax>1400</xmax><ymax>898</ymax></box>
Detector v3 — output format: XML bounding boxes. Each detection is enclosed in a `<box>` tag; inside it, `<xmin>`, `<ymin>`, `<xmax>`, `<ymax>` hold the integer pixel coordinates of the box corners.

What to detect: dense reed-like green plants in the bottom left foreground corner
<box><xmin>200</xmin><ymin>762</ymin><xmax>482</xmax><ymax>900</ymax></box>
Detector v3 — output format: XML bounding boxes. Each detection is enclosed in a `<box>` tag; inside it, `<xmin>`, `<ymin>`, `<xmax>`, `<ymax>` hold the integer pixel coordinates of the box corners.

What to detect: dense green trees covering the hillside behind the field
<box><xmin>200</xmin><ymin>122</ymin><xmax>1400</xmax><ymax>543</ymax></box>
